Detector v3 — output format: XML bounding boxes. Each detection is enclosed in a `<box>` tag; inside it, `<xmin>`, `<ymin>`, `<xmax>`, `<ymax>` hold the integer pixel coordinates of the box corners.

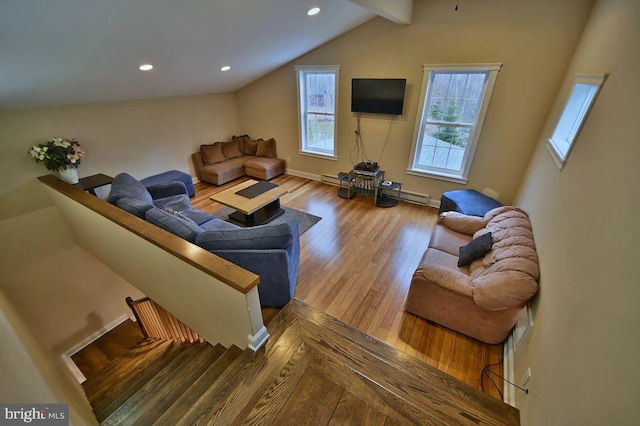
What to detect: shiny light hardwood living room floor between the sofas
<box><xmin>192</xmin><ymin>175</ymin><xmax>502</xmax><ymax>399</ymax></box>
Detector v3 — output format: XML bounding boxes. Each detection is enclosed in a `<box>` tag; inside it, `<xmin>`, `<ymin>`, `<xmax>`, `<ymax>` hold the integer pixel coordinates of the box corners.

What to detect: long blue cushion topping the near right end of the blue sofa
<box><xmin>196</xmin><ymin>223</ymin><xmax>297</xmax><ymax>250</ymax></box>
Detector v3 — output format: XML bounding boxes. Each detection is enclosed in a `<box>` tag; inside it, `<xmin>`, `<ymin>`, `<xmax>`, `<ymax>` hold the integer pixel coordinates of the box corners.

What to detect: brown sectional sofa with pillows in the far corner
<box><xmin>191</xmin><ymin>135</ymin><xmax>286</xmax><ymax>185</ymax></box>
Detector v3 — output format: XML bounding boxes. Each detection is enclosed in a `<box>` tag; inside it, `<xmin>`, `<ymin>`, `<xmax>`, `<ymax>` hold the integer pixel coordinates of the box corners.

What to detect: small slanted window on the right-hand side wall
<box><xmin>547</xmin><ymin>74</ymin><xmax>607</xmax><ymax>169</ymax></box>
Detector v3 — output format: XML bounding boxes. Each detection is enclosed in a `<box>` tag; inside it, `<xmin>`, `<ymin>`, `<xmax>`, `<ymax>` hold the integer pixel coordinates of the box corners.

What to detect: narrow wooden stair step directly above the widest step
<box><xmin>152</xmin><ymin>346</ymin><xmax>243</xmax><ymax>426</ymax></box>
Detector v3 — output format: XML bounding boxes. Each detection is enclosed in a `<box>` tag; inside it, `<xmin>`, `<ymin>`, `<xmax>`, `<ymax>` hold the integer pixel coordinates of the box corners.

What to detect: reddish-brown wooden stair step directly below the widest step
<box><xmin>89</xmin><ymin>341</ymin><xmax>188</xmax><ymax>422</ymax></box>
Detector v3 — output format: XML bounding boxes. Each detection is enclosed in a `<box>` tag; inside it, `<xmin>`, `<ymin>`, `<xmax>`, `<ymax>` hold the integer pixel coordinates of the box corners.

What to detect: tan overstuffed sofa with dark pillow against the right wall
<box><xmin>405</xmin><ymin>206</ymin><xmax>539</xmax><ymax>344</ymax></box>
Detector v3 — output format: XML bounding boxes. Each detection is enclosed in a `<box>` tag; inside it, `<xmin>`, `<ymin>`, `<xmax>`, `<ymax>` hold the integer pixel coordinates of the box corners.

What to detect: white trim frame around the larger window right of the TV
<box><xmin>406</xmin><ymin>63</ymin><xmax>502</xmax><ymax>184</ymax></box>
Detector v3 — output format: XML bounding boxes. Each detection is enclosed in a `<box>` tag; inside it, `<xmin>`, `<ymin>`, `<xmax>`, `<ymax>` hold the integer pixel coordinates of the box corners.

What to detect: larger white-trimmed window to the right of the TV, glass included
<box><xmin>407</xmin><ymin>64</ymin><xmax>502</xmax><ymax>183</ymax></box>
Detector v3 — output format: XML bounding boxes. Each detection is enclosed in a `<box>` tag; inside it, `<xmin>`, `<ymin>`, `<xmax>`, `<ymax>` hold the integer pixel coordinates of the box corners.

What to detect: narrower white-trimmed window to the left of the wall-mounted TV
<box><xmin>295</xmin><ymin>65</ymin><xmax>340</xmax><ymax>158</ymax></box>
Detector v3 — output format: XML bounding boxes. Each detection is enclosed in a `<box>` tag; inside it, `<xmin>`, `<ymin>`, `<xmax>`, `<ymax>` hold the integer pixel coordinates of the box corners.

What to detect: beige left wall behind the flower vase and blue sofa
<box><xmin>0</xmin><ymin>94</ymin><xmax>240</xmax><ymax>199</ymax></box>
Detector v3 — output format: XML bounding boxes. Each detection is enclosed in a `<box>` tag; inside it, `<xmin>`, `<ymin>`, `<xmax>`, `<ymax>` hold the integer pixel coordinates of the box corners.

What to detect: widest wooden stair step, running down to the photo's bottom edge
<box><xmin>102</xmin><ymin>343</ymin><xmax>225</xmax><ymax>426</ymax></box>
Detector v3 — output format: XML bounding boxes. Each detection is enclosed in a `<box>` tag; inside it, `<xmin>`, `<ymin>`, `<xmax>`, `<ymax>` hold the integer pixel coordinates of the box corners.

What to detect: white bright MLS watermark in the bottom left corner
<box><xmin>0</xmin><ymin>403</ymin><xmax>69</xmax><ymax>426</ymax></box>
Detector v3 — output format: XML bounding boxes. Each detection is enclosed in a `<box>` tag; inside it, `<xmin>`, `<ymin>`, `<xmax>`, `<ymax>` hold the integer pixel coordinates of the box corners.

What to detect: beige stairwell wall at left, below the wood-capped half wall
<box><xmin>0</xmin><ymin>207</ymin><xmax>144</xmax><ymax>354</ymax></box>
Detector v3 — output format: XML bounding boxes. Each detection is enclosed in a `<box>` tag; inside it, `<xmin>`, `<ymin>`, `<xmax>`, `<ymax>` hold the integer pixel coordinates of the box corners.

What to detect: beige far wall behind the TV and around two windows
<box><xmin>238</xmin><ymin>0</ymin><xmax>593</xmax><ymax>203</ymax></box>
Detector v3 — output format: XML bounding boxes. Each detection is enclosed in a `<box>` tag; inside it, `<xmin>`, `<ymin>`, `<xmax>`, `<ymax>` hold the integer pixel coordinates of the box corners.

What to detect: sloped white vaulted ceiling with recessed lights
<box><xmin>0</xmin><ymin>0</ymin><xmax>412</xmax><ymax>109</ymax></box>
